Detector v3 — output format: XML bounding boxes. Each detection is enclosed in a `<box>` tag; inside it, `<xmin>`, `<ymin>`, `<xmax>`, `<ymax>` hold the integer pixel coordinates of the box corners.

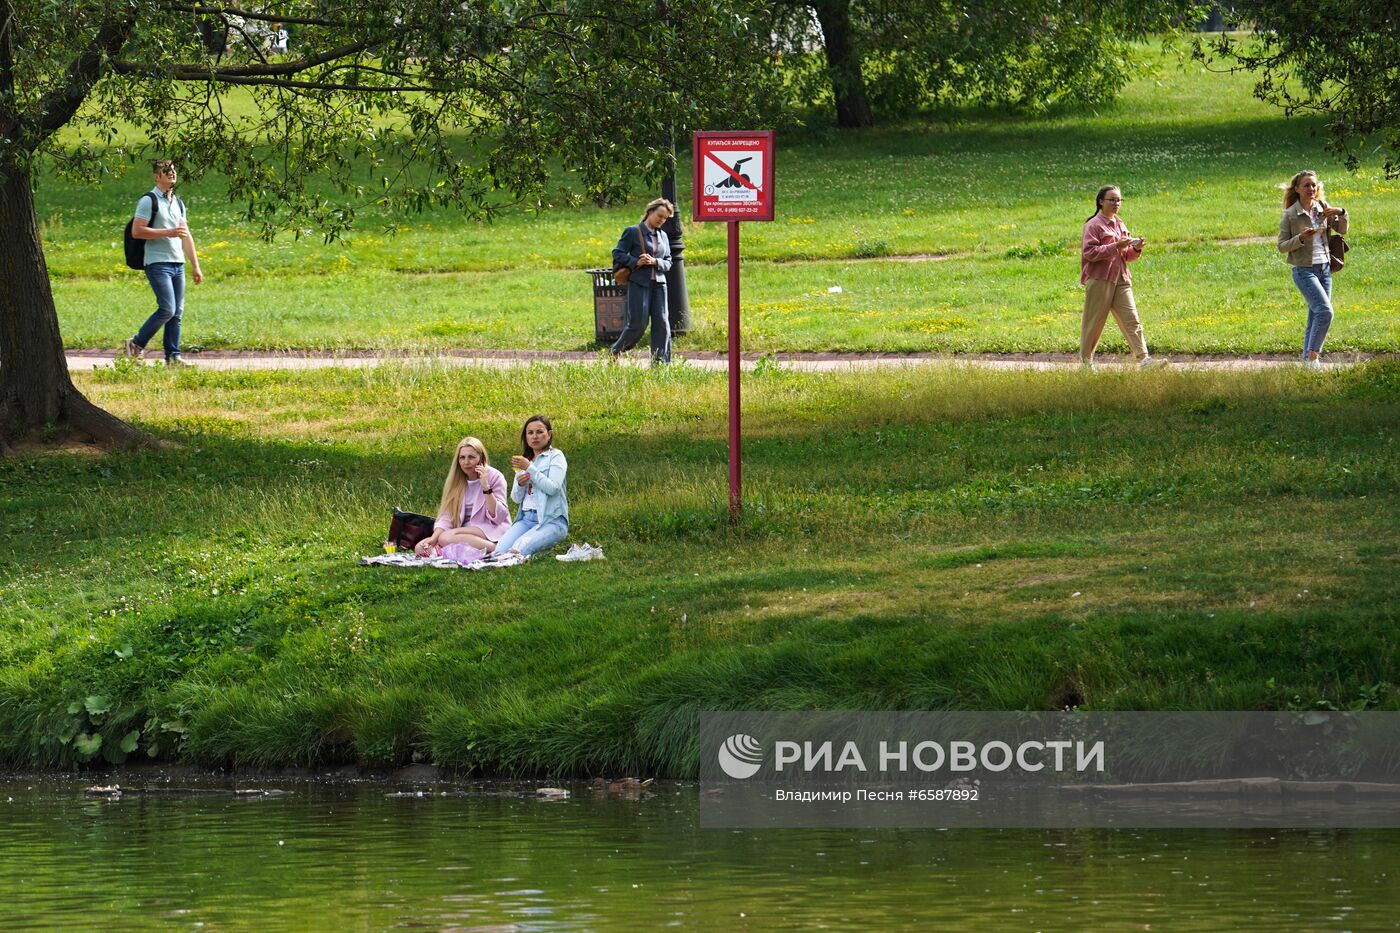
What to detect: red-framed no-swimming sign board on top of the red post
<box><xmin>693</xmin><ymin>130</ymin><xmax>773</xmax><ymax>220</ymax></box>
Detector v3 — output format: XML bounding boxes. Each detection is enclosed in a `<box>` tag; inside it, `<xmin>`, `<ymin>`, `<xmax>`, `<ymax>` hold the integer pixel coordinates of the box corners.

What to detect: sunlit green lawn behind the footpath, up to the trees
<box><xmin>38</xmin><ymin>40</ymin><xmax>1400</xmax><ymax>353</ymax></box>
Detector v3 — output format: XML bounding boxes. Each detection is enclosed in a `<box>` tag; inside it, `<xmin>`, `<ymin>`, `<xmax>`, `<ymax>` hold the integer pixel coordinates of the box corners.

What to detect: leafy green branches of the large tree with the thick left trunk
<box><xmin>0</xmin><ymin>0</ymin><xmax>773</xmax><ymax>228</ymax></box>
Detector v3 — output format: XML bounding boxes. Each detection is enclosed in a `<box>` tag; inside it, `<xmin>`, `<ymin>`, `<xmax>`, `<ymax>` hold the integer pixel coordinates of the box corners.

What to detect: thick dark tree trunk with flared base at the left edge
<box><xmin>0</xmin><ymin>165</ymin><xmax>144</xmax><ymax>447</ymax></box>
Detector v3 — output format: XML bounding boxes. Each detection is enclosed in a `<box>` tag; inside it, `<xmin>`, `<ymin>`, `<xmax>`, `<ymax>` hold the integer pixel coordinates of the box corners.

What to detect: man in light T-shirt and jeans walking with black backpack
<box><xmin>122</xmin><ymin>158</ymin><xmax>204</xmax><ymax>366</ymax></box>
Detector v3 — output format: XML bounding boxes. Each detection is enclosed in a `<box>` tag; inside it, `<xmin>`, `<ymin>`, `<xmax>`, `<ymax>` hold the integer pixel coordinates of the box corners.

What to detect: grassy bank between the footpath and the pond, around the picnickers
<box><xmin>0</xmin><ymin>364</ymin><xmax>1400</xmax><ymax>775</ymax></box>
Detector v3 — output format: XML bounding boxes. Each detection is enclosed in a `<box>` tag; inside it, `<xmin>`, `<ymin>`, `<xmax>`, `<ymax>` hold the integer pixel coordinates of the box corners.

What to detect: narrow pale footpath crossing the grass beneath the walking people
<box><xmin>67</xmin><ymin>350</ymin><xmax>1392</xmax><ymax>373</ymax></box>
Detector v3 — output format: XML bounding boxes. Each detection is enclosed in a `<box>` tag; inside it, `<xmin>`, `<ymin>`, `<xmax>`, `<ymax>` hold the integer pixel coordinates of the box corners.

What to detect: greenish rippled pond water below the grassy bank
<box><xmin>0</xmin><ymin>776</ymin><xmax>1400</xmax><ymax>932</ymax></box>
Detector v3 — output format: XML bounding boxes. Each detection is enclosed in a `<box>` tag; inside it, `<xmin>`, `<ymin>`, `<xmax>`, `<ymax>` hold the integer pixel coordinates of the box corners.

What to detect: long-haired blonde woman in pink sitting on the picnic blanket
<box><xmin>414</xmin><ymin>437</ymin><xmax>511</xmax><ymax>563</ymax></box>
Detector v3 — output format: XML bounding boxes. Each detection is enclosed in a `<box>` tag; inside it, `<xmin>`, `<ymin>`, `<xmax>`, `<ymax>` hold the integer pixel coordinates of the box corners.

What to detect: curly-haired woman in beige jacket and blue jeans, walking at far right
<box><xmin>1278</xmin><ymin>171</ymin><xmax>1351</xmax><ymax>370</ymax></box>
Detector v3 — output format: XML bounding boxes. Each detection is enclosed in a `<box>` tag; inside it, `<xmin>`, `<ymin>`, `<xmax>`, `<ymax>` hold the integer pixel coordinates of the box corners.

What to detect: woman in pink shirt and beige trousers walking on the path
<box><xmin>1079</xmin><ymin>185</ymin><xmax>1156</xmax><ymax>368</ymax></box>
